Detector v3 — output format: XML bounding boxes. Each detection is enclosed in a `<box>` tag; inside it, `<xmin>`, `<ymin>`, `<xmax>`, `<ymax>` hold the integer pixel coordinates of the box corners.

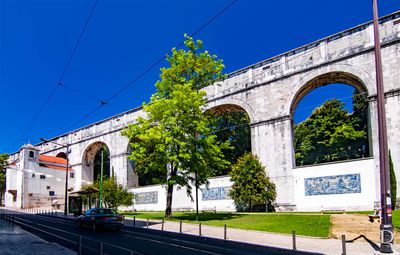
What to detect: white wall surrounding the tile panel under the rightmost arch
<box><xmin>293</xmin><ymin>159</ymin><xmax>376</xmax><ymax>211</ymax></box>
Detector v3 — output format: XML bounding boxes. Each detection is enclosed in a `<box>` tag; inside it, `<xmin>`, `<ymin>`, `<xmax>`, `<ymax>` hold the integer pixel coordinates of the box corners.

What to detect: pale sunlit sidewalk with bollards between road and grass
<box><xmin>125</xmin><ymin>218</ymin><xmax>400</xmax><ymax>255</ymax></box>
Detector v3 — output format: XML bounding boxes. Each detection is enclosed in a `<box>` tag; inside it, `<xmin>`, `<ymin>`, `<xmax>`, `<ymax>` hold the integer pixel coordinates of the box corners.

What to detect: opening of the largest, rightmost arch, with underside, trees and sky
<box><xmin>290</xmin><ymin>72</ymin><xmax>372</xmax><ymax>166</ymax></box>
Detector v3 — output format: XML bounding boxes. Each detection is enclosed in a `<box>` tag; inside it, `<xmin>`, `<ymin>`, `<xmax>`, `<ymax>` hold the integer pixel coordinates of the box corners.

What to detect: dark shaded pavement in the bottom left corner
<box><xmin>0</xmin><ymin>220</ymin><xmax>76</xmax><ymax>255</ymax></box>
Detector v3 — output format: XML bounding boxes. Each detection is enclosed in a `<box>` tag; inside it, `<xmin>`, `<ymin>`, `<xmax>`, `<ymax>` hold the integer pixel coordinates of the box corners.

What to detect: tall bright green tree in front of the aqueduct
<box><xmin>122</xmin><ymin>35</ymin><xmax>233</xmax><ymax>218</ymax></box>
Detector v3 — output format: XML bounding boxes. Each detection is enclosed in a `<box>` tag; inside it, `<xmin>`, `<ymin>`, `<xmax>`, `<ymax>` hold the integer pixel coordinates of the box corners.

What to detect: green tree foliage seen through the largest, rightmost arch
<box><xmin>294</xmin><ymin>93</ymin><xmax>368</xmax><ymax>165</ymax></box>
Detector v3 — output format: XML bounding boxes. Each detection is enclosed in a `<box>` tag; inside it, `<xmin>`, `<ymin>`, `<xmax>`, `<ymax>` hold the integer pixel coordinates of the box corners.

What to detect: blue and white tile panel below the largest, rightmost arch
<box><xmin>304</xmin><ymin>174</ymin><xmax>361</xmax><ymax>196</ymax></box>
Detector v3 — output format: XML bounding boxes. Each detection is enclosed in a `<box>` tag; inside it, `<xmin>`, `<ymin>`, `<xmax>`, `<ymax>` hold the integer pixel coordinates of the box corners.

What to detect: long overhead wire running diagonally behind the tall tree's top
<box><xmin>70</xmin><ymin>0</ymin><xmax>239</xmax><ymax>128</ymax></box>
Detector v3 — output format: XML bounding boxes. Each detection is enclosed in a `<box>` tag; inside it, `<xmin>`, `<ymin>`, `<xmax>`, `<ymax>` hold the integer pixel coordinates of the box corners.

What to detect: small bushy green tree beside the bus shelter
<box><xmin>82</xmin><ymin>175</ymin><xmax>134</xmax><ymax>209</ymax></box>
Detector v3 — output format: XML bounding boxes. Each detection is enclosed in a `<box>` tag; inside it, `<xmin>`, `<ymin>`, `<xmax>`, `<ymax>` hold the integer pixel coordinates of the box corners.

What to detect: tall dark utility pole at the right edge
<box><xmin>372</xmin><ymin>0</ymin><xmax>394</xmax><ymax>253</ymax></box>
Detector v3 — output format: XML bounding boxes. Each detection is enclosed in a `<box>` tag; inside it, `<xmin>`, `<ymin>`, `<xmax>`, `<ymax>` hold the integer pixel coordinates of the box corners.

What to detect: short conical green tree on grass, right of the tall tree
<box><xmin>229</xmin><ymin>153</ymin><xmax>276</xmax><ymax>211</ymax></box>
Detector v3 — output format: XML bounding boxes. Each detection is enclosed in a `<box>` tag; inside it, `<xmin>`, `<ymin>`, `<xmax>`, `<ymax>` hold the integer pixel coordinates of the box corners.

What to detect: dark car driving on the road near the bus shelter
<box><xmin>76</xmin><ymin>208</ymin><xmax>124</xmax><ymax>231</ymax></box>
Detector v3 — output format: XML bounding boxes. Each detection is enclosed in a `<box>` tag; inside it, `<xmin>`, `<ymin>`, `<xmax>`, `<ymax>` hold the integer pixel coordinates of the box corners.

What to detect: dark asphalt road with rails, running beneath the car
<box><xmin>1</xmin><ymin>214</ymin><xmax>324</xmax><ymax>255</ymax></box>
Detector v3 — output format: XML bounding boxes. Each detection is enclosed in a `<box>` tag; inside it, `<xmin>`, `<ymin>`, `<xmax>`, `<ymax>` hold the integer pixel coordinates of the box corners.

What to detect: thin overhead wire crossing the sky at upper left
<box><xmin>22</xmin><ymin>0</ymin><xmax>98</xmax><ymax>139</ymax></box>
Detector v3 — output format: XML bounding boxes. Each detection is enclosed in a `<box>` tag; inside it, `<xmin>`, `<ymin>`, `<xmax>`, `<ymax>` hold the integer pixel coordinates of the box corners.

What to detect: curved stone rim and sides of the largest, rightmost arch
<box><xmin>287</xmin><ymin>70</ymin><xmax>372</xmax><ymax>166</ymax></box>
